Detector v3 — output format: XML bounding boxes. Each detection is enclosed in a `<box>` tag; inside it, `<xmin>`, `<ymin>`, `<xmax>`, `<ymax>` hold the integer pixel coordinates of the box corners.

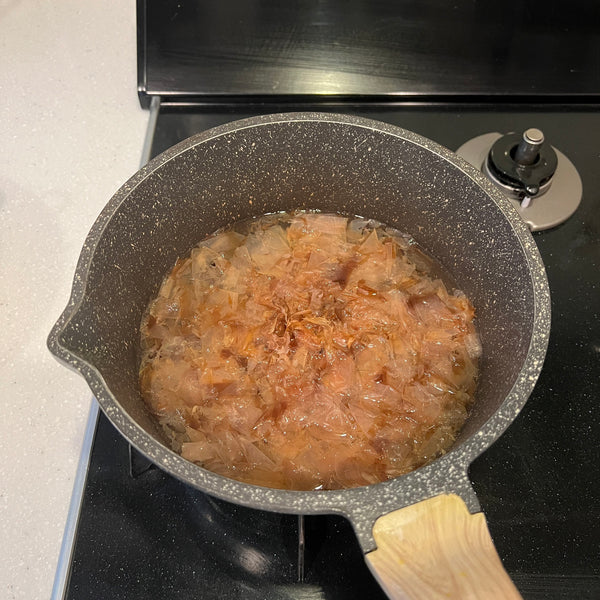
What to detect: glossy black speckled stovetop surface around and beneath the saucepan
<box><xmin>65</xmin><ymin>104</ymin><xmax>600</xmax><ymax>600</ymax></box>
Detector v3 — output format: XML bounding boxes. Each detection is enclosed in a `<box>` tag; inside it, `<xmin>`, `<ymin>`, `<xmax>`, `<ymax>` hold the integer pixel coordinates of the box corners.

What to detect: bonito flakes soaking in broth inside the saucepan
<box><xmin>140</xmin><ymin>212</ymin><xmax>480</xmax><ymax>490</ymax></box>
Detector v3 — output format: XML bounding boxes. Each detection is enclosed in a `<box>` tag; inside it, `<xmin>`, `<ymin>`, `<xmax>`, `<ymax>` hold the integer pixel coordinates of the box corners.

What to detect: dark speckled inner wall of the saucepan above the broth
<box><xmin>59</xmin><ymin>119</ymin><xmax>535</xmax><ymax>460</ymax></box>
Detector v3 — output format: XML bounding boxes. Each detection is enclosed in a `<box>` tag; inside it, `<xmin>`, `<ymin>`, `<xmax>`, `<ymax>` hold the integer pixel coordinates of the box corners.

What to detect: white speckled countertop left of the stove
<box><xmin>0</xmin><ymin>0</ymin><xmax>148</xmax><ymax>600</ymax></box>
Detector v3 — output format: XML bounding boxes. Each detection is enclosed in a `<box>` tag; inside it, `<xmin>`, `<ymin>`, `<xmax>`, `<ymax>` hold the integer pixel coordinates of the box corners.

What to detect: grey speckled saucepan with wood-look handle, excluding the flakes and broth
<box><xmin>48</xmin><ymin>113</ymin><xmax>550</xmax><ymax>598</ymax></box>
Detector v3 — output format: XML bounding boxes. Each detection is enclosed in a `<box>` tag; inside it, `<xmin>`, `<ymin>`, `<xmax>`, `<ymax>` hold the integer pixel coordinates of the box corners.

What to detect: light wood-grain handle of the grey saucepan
<box><xmin>366</xmin><ymin>494</ymin><xmax>521</xmax><ymax>600</ymax></box>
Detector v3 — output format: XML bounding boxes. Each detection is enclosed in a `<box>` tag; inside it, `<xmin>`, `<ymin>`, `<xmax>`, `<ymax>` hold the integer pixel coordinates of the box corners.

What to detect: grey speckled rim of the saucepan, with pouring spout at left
<box><xmin>48</xmin><ymin>112</ymin><xmax>550</xmax><ymax>547</ymax></box>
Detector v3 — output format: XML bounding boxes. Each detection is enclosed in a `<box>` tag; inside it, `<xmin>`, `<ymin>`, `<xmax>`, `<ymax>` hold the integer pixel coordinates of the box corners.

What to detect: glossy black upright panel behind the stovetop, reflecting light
<box><xmin>137</xmin><ymin>0</ymin><xmax>600</xmax><ymax>106</ymax></box>
